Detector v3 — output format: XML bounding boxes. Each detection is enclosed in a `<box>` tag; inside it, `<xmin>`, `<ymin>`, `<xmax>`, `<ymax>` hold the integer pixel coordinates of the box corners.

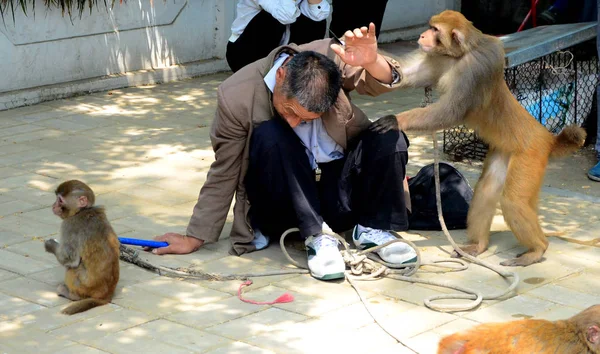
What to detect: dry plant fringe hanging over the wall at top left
<box><xmin>0</xmin><ymin>0</ymin><xmax>124</xmax><ymax>21</ymax></box>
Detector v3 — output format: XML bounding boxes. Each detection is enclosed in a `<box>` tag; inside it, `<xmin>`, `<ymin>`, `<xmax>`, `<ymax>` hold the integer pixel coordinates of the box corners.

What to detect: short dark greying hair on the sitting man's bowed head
<box><xmin>282</xmin><ymin>51</ymin><xmax>342</xmax><ymax>113</ymax></box>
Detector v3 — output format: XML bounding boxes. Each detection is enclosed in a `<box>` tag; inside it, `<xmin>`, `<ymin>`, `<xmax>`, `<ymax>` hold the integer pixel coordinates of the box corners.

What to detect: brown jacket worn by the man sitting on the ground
<box><xmin>186</xmin><ymin>39</ymin><xmax>401</xmax><ymax>255</ymax></box>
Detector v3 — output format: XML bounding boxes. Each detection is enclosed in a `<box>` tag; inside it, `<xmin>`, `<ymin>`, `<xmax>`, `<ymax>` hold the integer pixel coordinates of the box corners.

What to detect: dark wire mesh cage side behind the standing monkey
<box><xmin>444</xmin><ymin>38</ymin><xmax>599</xmax><ymax>161</ymax></box>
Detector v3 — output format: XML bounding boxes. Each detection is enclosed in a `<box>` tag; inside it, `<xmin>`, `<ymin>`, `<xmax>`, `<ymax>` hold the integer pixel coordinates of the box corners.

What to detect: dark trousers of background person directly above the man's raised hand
<box><xmin>329</xmin><ymin>0</ymin><xmax>388</xmax><ymax>37</ymax></box>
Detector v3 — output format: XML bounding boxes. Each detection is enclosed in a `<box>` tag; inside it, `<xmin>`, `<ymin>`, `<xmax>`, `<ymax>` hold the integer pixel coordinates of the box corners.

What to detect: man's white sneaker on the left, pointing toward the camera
<box><xmin>304</xmin><ymin>235</ymin><xmax>346</xmax><ymax>280</ymax></box>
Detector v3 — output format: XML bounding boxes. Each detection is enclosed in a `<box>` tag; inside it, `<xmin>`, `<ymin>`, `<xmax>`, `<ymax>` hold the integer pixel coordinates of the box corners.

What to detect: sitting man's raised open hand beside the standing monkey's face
<box><xmin>331</xmin><ymin>22</ymin><xmax>377</xmax><ymax>67</ymax></box>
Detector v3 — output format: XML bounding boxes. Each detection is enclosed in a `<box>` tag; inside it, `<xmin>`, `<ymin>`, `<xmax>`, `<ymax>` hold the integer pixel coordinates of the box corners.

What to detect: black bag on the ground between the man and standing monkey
<box><xmin>408</xmin><ymin>162</ymin><xmax>473</xmax><ymax>231</ymax></box>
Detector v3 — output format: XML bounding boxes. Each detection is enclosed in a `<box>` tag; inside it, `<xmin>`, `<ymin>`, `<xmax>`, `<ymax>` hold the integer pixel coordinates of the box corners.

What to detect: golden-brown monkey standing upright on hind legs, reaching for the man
<box><xmin>373</xmin><ymin>10</ymin><xmax>585</xmax><ymax>266</ymax></box>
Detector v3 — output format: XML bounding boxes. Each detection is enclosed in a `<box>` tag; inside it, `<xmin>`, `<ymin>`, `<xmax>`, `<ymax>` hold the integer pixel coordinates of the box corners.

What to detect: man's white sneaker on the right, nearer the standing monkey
<box><xmin>352</xmin><ymin>225</ymin><xmax>417</xmax><ymax>264</ymax></box>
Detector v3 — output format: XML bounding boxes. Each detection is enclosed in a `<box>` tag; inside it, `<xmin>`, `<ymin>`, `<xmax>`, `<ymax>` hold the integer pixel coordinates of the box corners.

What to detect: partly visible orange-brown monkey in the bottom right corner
<box><xmin>438</xmin><ymin>305</ymin><xmax>600</xmax><ymax>354</ymax></box>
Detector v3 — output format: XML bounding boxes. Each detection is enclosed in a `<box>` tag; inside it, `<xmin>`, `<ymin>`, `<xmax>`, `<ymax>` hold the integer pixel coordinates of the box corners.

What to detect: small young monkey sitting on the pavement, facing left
<box><xmin>44</xmin><ymin>180</ymin><xmax>119</xmax><ymax>315</ymax></box>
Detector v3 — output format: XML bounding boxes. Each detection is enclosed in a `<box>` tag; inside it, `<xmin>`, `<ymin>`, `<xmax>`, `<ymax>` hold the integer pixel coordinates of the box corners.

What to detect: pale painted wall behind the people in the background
<box><xmin>0</xmin><ymin>0</ymin><xmax>459</xmax><ymax>110</ymax></box>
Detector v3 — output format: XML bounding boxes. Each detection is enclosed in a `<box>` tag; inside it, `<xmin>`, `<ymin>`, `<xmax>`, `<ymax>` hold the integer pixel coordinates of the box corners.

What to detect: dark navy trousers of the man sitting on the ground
<box><xmin>245</xmin><ymin>117</ymin><xmax>408</xmax><ymax>238</ymax></box>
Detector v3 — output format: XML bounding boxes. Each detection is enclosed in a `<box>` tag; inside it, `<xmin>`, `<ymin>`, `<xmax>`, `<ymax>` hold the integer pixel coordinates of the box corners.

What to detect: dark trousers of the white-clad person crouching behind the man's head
<box><xmin>225</xmin><ymin>10</ymin><xmax>327</xmax><ymax>72</ymax></box>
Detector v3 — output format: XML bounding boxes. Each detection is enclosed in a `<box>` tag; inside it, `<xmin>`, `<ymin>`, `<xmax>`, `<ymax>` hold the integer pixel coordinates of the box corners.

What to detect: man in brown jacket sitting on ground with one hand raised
<box><xmin>153</xmin><ymin>24</ymin><xmax>416</xmax><ymax>279</ymax></box>
